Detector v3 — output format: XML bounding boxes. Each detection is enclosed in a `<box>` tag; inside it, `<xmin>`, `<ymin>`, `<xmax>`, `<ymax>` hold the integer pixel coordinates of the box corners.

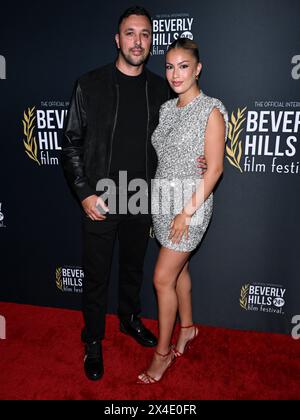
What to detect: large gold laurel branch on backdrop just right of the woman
<box><xmin>226</xmin><ymin>107</ymin><xmax>247</xmax><ymax>173</ymax></box>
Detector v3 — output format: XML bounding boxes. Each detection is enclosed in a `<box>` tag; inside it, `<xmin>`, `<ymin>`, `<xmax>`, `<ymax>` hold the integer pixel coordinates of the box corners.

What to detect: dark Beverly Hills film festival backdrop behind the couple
<box><xmin>0</xmin><ymin>0</ymin><xmax>300</xmax><ymax>333</ymax></box>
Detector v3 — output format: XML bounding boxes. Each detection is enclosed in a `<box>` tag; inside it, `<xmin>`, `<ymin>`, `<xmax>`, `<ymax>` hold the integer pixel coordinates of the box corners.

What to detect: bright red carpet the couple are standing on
<box><xmin>0</xmin><ymin>303</ymin><xmax>300</xmax><ymax>400</ymax></box>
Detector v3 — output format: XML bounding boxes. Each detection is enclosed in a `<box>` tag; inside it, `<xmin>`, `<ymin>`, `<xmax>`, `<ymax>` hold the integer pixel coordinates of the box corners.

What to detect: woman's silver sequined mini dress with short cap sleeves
<box><xmin>151</xmin><ymin>91</ymin><xmax>228</xmax><ymax>252</ymax></box>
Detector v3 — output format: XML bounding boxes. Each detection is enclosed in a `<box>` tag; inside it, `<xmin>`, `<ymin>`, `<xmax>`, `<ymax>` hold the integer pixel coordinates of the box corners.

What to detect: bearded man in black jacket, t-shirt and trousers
<box><xmin>62</xmin><ymin>7</ymin><xmax>205</xmax><ymax>380</ymax></box>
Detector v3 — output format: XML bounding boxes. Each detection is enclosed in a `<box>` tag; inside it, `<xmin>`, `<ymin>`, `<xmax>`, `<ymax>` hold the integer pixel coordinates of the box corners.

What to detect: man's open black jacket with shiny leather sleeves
<box><xmin>62</xmin><ymin>63</ymin><xmax>169</xmax><ymax>201</ymax></box>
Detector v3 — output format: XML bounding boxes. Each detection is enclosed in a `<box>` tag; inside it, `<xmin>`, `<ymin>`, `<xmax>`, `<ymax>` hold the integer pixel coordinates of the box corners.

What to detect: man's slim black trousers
<box><xmin>83</xmin><ymin>208</ymin><xmax>151</xmax><ymax>341</ymax></box>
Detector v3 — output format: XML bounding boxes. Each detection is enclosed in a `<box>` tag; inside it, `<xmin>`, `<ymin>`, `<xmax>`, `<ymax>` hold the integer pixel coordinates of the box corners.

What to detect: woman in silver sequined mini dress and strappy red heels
<box><xmin>138</xmin><ymin>38</ymin><xmax>228</xmax><ymax>384</ymax></box>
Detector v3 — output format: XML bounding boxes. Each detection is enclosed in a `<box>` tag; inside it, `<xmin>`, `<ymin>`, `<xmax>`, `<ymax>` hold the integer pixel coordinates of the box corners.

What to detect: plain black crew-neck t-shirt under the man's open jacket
<box><xmin>110</xmin><ymin>69</ymin><xmax>147</xmax><ymax>184</ymax></box>
